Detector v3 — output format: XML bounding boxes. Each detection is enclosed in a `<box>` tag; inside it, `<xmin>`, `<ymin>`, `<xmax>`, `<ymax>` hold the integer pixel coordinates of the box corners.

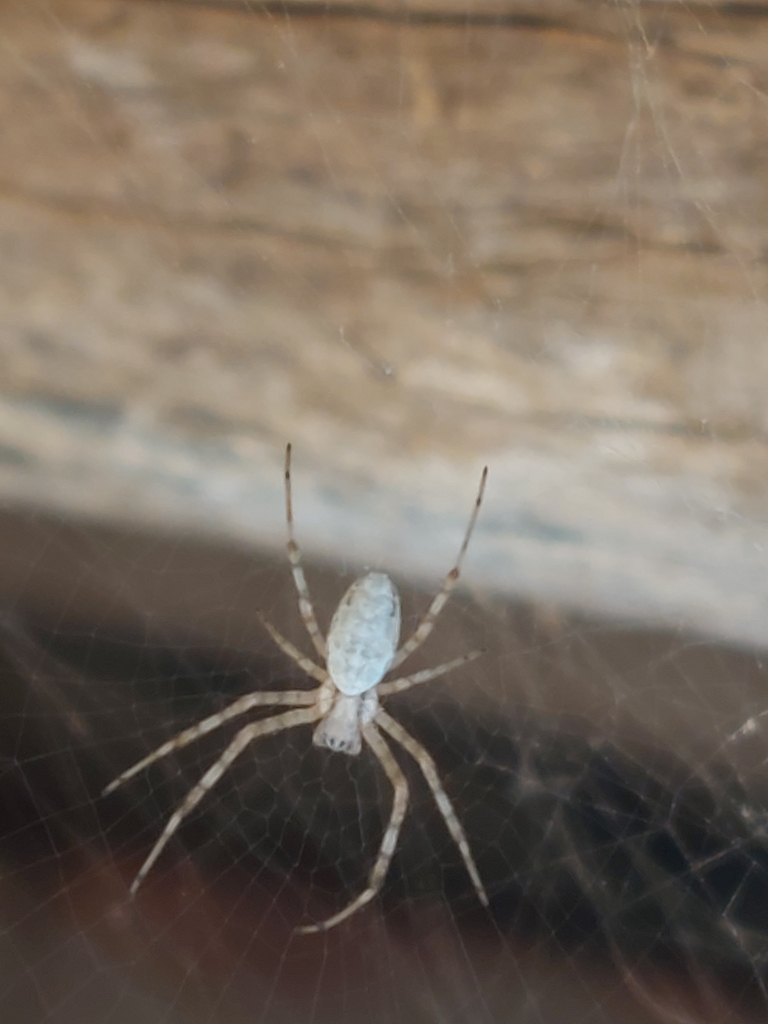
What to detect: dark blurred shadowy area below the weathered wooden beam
<box><xmin>0</xmin><ymin>518</ymin><xmax>768</xmax><ymax>1022</ymax></box>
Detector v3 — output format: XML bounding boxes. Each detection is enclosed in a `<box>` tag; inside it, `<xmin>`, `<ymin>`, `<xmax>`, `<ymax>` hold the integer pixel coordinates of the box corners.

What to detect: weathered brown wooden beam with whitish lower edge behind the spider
<box><xmin>0</xmin><ymin>0</ymin><xmax>768</xmax><ymax>643</ymax></box>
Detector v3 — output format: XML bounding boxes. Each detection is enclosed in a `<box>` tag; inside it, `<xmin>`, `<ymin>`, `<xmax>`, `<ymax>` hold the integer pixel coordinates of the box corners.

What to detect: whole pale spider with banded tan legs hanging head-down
<box><xmin>103</xmin><ymin>444</ymin><xmax>488</xmax><ymax>934</ymax></box>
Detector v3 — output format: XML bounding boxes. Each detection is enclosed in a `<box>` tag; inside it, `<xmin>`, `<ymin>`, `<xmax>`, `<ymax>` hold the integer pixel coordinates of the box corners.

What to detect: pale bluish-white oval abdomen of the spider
<box><xmin>327</xmin><ymin>572</ymin><xmax>400</xmax><ymax>696</ymax></box>
